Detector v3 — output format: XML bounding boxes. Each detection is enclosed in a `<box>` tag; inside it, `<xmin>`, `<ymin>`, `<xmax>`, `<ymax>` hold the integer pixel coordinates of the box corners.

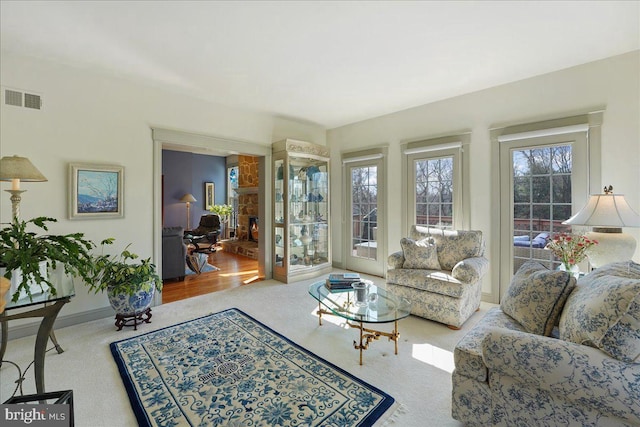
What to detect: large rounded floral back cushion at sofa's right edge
<box><xmin>559</xmin><ymin>261</ymin><xmax>640</xmax><ymax>363</ymax></box>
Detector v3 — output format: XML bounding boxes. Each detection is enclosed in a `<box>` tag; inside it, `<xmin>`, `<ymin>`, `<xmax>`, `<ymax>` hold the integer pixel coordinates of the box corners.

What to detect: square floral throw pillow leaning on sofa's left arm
<box><xmin>500</xmin><ymin>261</ymin><xmax>576</xmax><ymax>337</ymax></box>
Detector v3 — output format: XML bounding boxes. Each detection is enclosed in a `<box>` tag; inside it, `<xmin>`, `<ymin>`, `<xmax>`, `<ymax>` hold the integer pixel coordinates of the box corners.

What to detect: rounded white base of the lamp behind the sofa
<box><xmin>585</xmin><ymin>227</ymin><xmax>636</xmax><ymax>268</ymax></box>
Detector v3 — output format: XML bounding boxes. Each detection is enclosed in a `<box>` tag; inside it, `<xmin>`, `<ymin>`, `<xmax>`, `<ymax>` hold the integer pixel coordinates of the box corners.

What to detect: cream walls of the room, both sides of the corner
<box><xmin>0</xmin><ymin>52</ymin><xmax>640</xmax><ymax>315</ymax></box>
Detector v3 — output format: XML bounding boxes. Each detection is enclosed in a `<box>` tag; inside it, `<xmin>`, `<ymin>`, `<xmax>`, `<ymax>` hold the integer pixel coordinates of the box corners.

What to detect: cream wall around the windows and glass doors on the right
<box><xmin>327</xmin><ymin>51</ymin><xmax>640</xmax><ymax>299</ymax></box>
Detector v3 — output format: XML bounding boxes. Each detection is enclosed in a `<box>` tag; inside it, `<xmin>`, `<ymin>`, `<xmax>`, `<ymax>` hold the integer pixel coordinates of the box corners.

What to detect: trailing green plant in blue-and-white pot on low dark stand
<box><xmin>87</xmin><ymin>238</ymin><xmax>162</xmax><ymax>316</ymax></box>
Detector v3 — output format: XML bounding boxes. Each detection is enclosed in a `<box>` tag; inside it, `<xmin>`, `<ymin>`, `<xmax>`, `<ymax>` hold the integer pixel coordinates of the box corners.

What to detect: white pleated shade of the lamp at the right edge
<box><xmin>563</xmin><ymin>194</ymin><xmax>640</xmax><ymax>227</ymax></box>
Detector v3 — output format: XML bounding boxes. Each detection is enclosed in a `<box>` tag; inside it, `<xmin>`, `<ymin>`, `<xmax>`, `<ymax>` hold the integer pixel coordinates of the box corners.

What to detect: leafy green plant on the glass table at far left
<box><xmin>0</xmin><ymin>217</ymin><xmax>95</xmax><ymax>302</ymax></box>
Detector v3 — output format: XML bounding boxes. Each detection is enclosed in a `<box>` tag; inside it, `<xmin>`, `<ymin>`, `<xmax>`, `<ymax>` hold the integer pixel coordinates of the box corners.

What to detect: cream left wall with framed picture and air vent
<box><xmin>0</xmin><ymin>53</ymin><xmax>326</xmax><ymax>316</ymax></box>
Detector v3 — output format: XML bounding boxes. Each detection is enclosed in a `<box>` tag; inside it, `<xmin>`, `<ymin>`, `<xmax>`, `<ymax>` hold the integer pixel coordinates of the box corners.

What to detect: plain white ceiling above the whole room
<box><xmin>0</xmin><ymin>0</ymin><xmax>640</xmax><ymax>129</ymax></box>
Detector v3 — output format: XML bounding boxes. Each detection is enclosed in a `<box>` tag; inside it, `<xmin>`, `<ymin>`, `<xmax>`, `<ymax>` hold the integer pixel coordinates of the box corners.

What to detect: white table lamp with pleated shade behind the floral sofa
<box><xmin>563</xmin><ymin>185</ymin><xmax>640</xmax><ymax>268</ymax></box>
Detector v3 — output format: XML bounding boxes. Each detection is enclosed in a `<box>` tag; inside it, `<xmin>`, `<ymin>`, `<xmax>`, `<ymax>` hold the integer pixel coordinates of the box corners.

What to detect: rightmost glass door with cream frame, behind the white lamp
<box><xmin>490</xmin><ymin>111</ymin><xmax>602</xmax><ymax>302</ymax></box>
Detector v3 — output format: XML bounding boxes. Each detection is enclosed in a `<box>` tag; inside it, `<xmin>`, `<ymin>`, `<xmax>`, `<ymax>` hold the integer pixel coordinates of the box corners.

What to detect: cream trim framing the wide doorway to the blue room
<box><xmin>151</xmin><ymin>127</ymin><xmax>273</xmax><ymax>305</ymax></box>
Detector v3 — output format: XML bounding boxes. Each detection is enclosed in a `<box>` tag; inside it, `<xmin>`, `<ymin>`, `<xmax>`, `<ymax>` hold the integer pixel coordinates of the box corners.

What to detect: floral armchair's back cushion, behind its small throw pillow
<box><xmin>409</xmin><ymin>225</ymin><xmax>484</xmax><ymax>271</ymax></box>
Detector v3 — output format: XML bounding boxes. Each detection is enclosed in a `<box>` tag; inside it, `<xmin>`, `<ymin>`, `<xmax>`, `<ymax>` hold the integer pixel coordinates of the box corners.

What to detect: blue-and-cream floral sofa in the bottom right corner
<box><xmin>452</xmin><ymin>261</ymin><xmax>640</xmax><ymax>426</ymax></box>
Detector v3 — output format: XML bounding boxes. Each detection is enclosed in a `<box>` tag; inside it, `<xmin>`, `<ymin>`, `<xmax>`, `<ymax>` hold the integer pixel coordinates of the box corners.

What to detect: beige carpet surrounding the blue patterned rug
<box><xmin>0</xmin><ymin>277</ymin><xmax>491</xmax><ymax>427</ymax></box>
